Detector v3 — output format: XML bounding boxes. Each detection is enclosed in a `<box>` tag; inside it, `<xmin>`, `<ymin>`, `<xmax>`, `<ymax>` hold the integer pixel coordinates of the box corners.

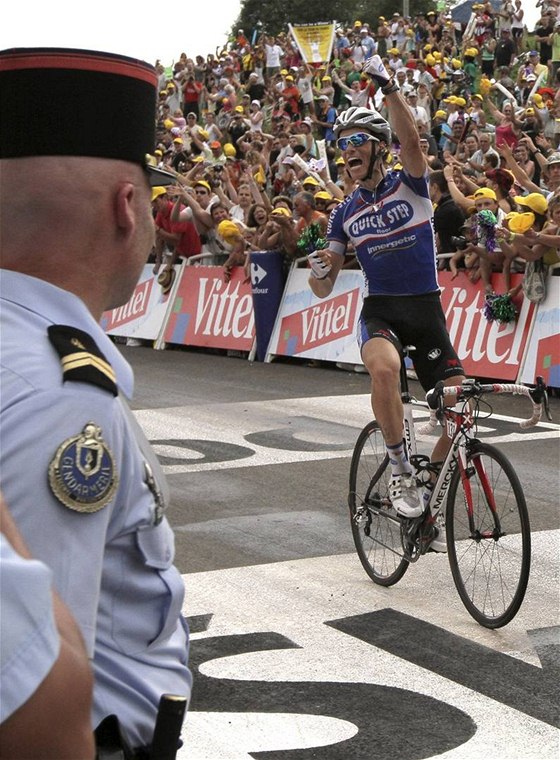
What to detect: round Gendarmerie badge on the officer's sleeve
<box><xmin>49</xmin><ymin>422</ymin><xmax>118</xmax><ymax>512</ymax></box>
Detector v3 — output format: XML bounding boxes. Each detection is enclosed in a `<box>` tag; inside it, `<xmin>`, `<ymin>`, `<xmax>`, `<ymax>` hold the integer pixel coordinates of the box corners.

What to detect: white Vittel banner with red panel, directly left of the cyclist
<box><xmin>267</xmin><ymin>269</ymin><xmax>363</xmax><ymax>364</ymax></box>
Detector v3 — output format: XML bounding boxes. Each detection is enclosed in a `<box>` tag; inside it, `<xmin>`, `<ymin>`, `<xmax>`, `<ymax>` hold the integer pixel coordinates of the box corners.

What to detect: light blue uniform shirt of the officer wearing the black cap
<box><xmin>0</xmin><ymin>270</ymin><xmax>191</xmax><ymax>746</ymax></box>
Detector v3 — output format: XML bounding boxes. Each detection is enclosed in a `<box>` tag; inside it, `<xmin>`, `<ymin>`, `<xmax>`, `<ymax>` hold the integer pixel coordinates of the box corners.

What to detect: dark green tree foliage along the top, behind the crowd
<box><xmin>232</xmin><ymin>0</ymin><xmax>435</xmax><ymax>40</ymax></box>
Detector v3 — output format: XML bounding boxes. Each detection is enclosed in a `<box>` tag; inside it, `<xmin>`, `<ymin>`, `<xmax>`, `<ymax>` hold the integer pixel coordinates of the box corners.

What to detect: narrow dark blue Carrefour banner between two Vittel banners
<box><xmin>251</xmin><ymin>251</ymin><xmax>284</xmax><ymax>362</ymax></box>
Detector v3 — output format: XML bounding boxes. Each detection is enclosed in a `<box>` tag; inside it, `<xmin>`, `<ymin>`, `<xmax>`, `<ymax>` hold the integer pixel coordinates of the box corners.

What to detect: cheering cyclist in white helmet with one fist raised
<box><xmin>308</xmin><ymin>56</ymin><xmax>463</xmax><ymax>551</ymax></box>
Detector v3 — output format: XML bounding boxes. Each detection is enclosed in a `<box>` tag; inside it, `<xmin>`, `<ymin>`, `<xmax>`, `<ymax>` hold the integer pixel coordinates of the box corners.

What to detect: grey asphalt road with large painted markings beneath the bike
<box><xmin>123</xmin><ymin>347</ymin><xmax>560</xmax><ymax>760</ymax></box>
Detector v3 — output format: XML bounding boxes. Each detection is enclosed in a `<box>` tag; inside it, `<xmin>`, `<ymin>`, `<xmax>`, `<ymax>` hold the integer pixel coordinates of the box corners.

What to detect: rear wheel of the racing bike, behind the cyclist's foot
<box><xmin>348</xmin><ymin>422</ymin><xmax>408</xmax><ymax>586</ymax></box>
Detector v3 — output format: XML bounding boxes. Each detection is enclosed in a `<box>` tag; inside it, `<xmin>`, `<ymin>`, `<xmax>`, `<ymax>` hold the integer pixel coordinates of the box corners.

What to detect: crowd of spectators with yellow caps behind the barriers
<box><xmin>148</xmin><ymin>0</ymin><xmax>560</xmax><ymax>302</ymax></box>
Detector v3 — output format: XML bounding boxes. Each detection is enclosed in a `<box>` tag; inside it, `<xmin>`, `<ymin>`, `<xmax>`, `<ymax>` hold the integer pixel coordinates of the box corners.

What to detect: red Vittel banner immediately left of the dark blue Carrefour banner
<box><xmin>164</xmin><ymin>266</ymin><xmax>255</xmax><ymax>351</ymax></box>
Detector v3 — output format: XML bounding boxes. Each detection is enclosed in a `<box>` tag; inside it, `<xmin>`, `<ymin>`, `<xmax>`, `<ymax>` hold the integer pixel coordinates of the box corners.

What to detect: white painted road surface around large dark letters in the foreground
<box><xmin>178</xmin><ymin>531</ymin><xmax>560</xmax><ymax>760</ymax></box>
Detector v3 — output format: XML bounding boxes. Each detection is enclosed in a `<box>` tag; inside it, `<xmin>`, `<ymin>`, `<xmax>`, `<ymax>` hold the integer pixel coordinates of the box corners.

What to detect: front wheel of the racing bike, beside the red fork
<box><xmin>446</xmin><ymin>442</ymin><xmax>531</xmax><ymax>628</ymax></box>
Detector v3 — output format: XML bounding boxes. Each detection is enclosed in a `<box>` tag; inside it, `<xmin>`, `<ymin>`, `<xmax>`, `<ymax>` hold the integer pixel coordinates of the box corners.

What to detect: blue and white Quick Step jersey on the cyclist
<box><xmin>327</xmin><ymin>171</ymin><xmax>439</xmax><ymax>296</ymax></box>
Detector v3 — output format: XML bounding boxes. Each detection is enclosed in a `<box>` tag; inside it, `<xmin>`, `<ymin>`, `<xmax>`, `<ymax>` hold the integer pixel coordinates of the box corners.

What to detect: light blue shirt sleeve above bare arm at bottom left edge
<box><xmin>0</xmin><ymin>533</ymin><xmax>60</xmax><ymax>723</ymax></box>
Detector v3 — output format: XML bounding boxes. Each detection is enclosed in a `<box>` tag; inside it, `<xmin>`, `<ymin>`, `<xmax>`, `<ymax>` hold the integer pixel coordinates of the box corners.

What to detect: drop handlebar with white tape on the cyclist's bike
<box><xmin>418</xmin><ymin>377</ymin><xmax>552</xmax><ymax>433</ymax></box>
